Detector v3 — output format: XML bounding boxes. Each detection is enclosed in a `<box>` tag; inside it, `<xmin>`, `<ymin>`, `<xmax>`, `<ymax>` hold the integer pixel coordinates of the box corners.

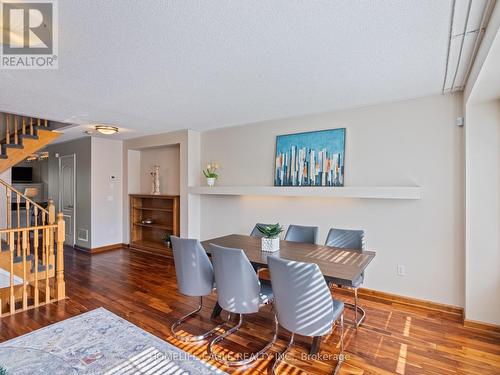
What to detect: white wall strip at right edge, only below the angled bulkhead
<box><xmin>465</xmin><ymin>100</ymin><xmax>500</xmax><ymax>325</ymax></box>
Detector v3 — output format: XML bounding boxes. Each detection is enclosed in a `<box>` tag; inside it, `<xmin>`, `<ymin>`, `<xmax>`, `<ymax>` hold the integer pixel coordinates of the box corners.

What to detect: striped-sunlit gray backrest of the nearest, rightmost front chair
<box><xmin>267</xmin><ymin>256</ymin><xmax>334</xmax><ymax>336</ymax></box>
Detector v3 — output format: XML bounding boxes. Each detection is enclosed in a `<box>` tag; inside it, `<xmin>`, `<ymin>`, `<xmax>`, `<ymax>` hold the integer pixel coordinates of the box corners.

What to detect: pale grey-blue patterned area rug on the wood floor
<box><xmin>0</xmin><ymin>308</ymin><xmax>225</xmax><ymax>375</ymax></box>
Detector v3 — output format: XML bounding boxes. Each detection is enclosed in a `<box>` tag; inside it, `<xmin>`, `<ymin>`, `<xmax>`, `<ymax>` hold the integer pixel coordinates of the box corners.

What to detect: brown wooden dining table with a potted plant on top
<box><xmin>201</xmin><ymin>234</ymin><xmax>375</xmax><ymax>354</ymax></box>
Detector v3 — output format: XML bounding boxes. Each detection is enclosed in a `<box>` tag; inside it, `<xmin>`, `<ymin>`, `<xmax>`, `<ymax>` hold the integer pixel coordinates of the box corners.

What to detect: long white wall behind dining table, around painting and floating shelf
<box><xmin>200</xmin><ymin>96</ymin><xmax>464</xmax><ymax>306</ymax></box>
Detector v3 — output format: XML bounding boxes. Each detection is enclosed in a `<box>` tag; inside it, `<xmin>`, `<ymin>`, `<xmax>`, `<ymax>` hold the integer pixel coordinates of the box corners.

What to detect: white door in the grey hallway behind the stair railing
<box><xmin>59</xmin><ymin>154</ymin><xmax>76</xmax><ymax>246</ymax></box>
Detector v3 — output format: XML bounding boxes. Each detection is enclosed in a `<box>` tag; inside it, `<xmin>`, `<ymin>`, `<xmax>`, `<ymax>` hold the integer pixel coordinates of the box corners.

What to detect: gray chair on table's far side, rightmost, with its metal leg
<box><xmin>325</xmin><ymin>228</ymin><xmax>366</xmax><ymax>328</ymax></box>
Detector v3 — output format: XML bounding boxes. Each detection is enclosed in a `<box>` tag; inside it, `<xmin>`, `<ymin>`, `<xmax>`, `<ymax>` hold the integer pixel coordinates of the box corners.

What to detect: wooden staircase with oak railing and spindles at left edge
<box><xmin>0</xmin><ymin>114</ymin><xmax>65</xmax><ymax>317</ymax></box>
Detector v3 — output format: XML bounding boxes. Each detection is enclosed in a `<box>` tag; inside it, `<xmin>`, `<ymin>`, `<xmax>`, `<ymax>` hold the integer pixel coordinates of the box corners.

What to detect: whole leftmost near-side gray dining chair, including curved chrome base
<box><xmin>170</xmin><ymin>236</ymin><xmax>223</xmax><ymax>341</ymax></box>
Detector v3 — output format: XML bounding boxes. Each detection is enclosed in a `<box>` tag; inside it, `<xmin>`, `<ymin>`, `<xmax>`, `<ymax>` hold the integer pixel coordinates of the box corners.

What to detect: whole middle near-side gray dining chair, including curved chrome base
<box><xmin>208</xmin><ymin>244</ymin><xmax>278</xmax><ymax>366</ymax></box>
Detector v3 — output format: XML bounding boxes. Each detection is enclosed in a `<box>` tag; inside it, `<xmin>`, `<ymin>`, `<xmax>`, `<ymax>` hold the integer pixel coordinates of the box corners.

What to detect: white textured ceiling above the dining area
<box><xmin>0</xmin><ymin>0</ymin><xmax>451</xmax><ymax>138</ymax></box>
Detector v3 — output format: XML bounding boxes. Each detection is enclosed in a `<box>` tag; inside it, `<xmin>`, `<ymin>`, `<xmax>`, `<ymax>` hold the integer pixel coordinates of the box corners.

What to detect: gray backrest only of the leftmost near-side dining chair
<box><xmin>170</xmin><ymin>236</ymin><xmax>214</xmax><ymax>297</ymax></box>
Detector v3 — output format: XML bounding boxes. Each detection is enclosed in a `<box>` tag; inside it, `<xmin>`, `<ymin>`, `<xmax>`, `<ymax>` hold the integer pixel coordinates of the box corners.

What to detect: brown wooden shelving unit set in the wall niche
<box><xmin>130</xmin><ymin>194</ymin><xmax>179</xmax><ymax>256</ymax></box>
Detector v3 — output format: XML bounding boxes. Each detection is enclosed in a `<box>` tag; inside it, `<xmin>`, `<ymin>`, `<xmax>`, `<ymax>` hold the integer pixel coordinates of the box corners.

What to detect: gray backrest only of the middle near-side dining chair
<box><xmin>210</xmin><ymin>244</ymin><xmax>260</xmax><ymax>314</ymax></box>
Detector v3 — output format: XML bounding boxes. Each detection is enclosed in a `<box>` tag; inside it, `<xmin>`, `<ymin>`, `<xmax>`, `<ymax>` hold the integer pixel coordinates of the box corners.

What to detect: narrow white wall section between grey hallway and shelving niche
<box><xmin>91</xmin><ymin>137</ymin><xmax>123</xmax><ymax>248</ymax></box>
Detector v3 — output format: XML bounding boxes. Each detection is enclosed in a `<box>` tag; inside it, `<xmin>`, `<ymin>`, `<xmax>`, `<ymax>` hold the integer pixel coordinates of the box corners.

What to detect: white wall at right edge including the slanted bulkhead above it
<box><xmin>464</xmin><ymin>8</ymin><xmax>500</xmax><ymax>325</ymax></box>
